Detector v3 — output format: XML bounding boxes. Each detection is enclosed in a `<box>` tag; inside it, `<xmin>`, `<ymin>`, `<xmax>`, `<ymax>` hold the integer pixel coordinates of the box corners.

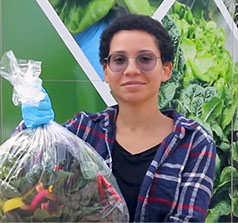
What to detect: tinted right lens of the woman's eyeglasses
<box><xmin>136</xmin><ymin>53</ymin><xmax>157</xmax><ymax>72</ymax></box>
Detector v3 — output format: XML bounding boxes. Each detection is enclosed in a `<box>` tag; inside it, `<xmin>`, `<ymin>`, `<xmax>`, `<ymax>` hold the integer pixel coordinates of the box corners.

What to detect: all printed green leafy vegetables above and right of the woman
<box><xmin>50</xmin><ymin>0</ymin><xmax>238</xmax><ymax>222</ymax></box>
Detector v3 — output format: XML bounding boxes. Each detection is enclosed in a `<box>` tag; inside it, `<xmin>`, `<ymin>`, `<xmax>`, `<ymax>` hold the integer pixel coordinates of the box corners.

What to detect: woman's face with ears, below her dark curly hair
<box><xmin>103</xmin><ymin>30</ymin><xmax>172</xmax><ymax>103</ymax></box>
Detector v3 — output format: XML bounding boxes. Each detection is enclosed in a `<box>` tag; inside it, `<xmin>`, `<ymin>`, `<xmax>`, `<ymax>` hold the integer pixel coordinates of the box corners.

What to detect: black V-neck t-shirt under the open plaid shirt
<box><xmin>112</xmin><ymin>142</ymin><xmax>158</xmax><ymax>222</ymax></box>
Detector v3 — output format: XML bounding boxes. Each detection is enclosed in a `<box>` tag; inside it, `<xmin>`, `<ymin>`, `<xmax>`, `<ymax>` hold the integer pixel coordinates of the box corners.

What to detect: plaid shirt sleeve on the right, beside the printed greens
<box><xmin>168</xmin><ymin>136</ymin><xmax>216</xmax><ymax>222</ymax></box>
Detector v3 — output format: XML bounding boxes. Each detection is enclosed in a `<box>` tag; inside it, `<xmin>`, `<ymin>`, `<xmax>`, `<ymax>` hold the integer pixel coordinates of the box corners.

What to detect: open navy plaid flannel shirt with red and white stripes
<box><xmin>14</xmin><ymin>106</ymin><xmax>216</xmax><ymax>222</ymax></box>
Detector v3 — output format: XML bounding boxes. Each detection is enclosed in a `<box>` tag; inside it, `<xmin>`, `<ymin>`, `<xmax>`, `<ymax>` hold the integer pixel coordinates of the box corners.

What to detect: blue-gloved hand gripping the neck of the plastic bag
<box><xmin>21</xmin><ymin>89</ymin><xmax>54</xmax><ymax>128</ymax></box>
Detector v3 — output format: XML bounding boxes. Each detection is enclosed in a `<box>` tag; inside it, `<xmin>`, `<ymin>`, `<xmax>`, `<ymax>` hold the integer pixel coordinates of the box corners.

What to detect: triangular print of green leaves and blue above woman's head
<box><xmin>49</xmin><ymin>0</ymin><xmax>164</xmax><ymax>80</ymax></box>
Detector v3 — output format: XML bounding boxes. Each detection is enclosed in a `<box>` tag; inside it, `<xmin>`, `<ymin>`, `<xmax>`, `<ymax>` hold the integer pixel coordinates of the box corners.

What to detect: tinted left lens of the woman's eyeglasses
<box><xmin>108</xmin><ymin>54</ymin><xmax>128</xmax><ymax>73</ymax></box>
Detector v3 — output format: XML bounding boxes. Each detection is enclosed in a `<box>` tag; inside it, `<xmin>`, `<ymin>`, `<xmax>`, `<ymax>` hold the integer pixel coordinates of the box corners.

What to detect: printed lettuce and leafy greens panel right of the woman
<box><xmin>160</xmin><ymin>2</ymin><xmax>238</xmax><ymax>222</ymax></box>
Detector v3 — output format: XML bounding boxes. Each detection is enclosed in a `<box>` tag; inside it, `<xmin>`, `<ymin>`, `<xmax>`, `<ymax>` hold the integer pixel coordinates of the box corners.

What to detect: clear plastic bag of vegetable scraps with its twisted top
<box><xmin>0</xmin><ymin>51</ymin><xmax>129</xmax><ymax>222</ymax></box>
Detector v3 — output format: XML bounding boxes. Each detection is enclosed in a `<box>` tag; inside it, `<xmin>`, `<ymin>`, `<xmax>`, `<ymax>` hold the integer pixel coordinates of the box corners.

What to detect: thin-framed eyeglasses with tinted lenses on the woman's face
<box><xmin>104</xmin><ymin>52</ymin><xmax>161</xmax><ymax>73</ymax></box>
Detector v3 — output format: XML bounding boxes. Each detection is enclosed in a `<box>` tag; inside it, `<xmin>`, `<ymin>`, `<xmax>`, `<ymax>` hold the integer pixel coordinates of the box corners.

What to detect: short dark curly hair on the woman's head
<box><xmin>99</xmin><ymin>14</ymin><xmax>174</xmax><ymax>64</ymax></box>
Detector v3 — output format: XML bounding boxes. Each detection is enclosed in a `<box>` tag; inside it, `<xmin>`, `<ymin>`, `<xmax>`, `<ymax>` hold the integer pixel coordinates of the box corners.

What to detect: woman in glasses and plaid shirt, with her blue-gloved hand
<box><xmin>22</xmin><ymin>15</ymin><xmax>215</xmax><ymax>222</ymax></box>
